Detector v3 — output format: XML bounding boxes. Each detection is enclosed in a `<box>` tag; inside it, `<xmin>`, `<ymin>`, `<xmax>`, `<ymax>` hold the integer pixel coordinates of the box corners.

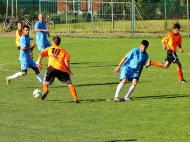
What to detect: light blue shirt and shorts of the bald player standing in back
<box><xmin>35</xmin><ymin>21</ymin><xmax>51</xmax><ymax>51</ymax></box>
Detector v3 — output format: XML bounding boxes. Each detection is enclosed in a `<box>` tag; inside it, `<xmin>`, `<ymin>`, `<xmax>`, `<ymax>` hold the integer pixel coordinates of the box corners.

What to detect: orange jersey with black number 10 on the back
<box><xmin>41</xmin><ymin>46</ymin><xmax>70</xmax><ymax>72</ymax></box>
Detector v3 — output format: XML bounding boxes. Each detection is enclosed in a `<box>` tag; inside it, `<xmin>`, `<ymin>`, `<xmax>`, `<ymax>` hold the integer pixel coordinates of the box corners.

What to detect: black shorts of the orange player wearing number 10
<box><xmin>44</xmin><ymin>66</ymin><xmax>71</xmax><ymax>85</ymax></box>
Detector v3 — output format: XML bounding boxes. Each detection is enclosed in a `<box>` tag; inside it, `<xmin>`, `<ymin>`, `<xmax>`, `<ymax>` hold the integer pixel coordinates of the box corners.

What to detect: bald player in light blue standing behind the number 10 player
<box><xmin>35</xmin><ymin>14</ymin><xmax>51</xmax><ymax>51</ymax></box>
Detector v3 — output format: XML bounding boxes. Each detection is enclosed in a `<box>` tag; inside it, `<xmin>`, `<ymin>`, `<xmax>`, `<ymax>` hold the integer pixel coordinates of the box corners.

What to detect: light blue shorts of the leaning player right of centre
<box><xmin>119</xmin><ymin>66</ymin><xmax>139</xmax><ymax>81</ymax></box>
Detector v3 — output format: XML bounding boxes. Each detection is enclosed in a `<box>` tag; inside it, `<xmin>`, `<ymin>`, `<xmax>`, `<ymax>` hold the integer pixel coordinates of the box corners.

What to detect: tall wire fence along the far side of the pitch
<box><xmin>0</xmin><ymin>0</ymin><xmax>190</xmax><ymax>35</ymax></box>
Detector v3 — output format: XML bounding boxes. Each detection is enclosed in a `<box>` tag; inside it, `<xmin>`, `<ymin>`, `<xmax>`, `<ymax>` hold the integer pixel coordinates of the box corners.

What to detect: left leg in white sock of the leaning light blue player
<box><xmin>113</xmin><ymin>79</ymin><xmax>127</xmax><ymax>102</ymax></box>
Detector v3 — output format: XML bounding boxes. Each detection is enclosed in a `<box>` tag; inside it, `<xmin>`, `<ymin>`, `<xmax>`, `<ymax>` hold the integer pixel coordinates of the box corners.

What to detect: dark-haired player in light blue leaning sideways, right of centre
<box><xmin>113</xmin><ymin>40</ymin><xmax>149</xmax><ymax>102</ymax></box>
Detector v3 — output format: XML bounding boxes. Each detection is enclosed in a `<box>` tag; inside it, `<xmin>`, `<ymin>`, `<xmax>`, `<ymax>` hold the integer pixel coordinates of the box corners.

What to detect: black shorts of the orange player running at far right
<box><xmin>165</xmin><ymin>50</ymin><xmax>179</xmax><ymax>64</ymax></box>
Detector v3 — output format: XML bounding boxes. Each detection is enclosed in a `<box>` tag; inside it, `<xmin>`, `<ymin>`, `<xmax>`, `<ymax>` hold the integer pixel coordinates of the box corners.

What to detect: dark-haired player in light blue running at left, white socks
<box><xmin>6</xmin><ymin>25</ymin><xmax>43</xmax><ymax>85</ymax></box>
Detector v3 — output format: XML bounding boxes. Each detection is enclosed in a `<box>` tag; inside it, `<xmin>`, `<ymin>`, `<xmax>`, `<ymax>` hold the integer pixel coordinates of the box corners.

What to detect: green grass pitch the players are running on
<box><xmin>0</xmin><ymin>38</ymin><xmax>190</xmax><ymax>142</ymax></box>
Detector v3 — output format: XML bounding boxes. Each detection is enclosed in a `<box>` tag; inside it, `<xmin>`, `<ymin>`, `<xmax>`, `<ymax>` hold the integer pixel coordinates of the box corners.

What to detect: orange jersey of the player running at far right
<box><xmin>162</xmin><ymin>32</ymin><xmax>182</xmax><ymax>52</ymax></box>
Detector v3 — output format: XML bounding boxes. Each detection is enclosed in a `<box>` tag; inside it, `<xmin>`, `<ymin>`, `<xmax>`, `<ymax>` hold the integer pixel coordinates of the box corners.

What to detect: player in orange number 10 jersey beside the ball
<box><xmin>36</xmin><ymin>36</ymin><xmax>79</xmax><ymax>103</ymax></box>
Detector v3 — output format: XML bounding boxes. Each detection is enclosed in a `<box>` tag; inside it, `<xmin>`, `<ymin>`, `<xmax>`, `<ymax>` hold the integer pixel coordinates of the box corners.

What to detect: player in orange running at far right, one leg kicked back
<box><xmin>146</xmin><ymin>23</ymin><xmax>186</xmax><ymax>83</ymax></box>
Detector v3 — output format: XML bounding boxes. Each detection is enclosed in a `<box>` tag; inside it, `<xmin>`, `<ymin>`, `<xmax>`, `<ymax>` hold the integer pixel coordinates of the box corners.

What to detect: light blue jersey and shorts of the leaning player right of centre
<box><xmin>120</xmin><ymin>48</ymin><xmax>148</xmax><ymax>81</ymax></box>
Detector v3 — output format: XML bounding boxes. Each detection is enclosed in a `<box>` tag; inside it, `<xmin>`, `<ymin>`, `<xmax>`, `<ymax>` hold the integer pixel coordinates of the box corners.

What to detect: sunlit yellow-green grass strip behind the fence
<box><xmin>50</xmin><ymin>19</ymin><xmax>189</xmax><ymax>33</ymax></box>
